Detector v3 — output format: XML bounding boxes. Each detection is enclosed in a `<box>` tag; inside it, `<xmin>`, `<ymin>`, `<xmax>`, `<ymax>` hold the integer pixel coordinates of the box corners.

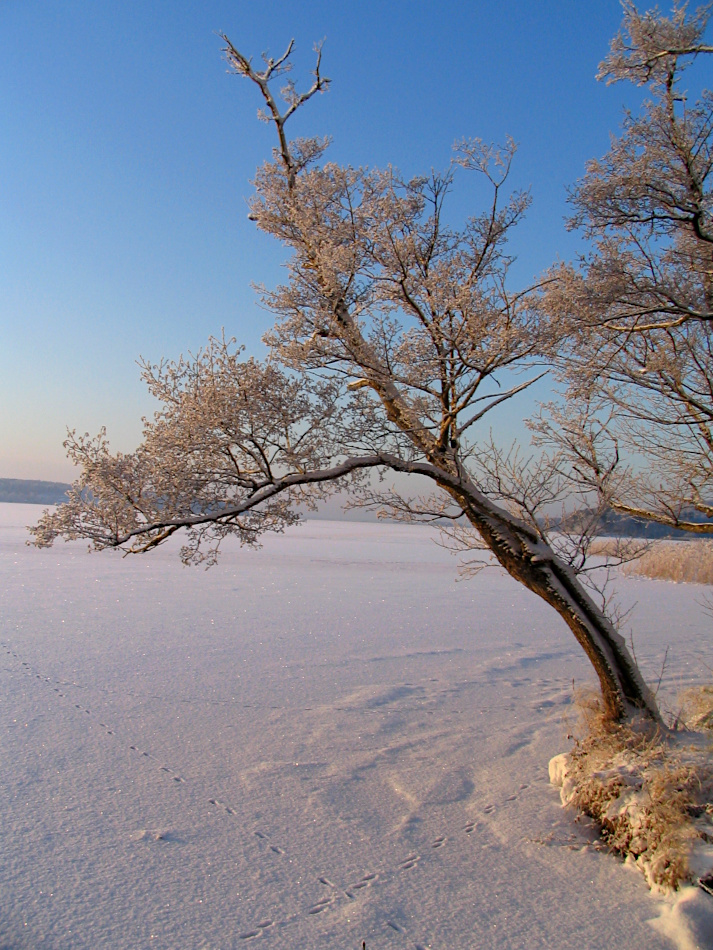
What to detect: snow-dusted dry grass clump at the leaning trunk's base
<box><xmin>550</xmin><ymin>690</ymin><xmax>713</xmax><ymax>889</ymax></box>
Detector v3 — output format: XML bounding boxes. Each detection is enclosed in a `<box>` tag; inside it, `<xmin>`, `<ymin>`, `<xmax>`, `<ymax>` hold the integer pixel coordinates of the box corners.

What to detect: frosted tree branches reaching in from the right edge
<box><xmin>536</xmin><ymin>2</ymin><xmax>713</xmax><ymax>534</ymax></box>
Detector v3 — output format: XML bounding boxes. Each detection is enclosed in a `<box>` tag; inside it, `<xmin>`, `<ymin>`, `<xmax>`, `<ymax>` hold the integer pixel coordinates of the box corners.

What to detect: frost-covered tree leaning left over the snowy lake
<box><xmin>34</xmin><ymin>20</ymin><xmax>659</xmax><ymax>721</ymax></box>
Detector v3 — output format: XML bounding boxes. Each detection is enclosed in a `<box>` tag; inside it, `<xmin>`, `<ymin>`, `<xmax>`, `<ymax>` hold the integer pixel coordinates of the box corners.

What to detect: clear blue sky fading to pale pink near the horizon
<box><xmin>0</xmin><ymin>0</ymin><xmax>660</xmax><ymax>480</ymax></box>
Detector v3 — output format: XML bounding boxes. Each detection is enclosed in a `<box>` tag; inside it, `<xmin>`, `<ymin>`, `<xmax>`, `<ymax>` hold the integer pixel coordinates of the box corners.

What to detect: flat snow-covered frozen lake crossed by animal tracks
<box><xmin>0</xmin><ymin>505</ymin><xmax>713</xmax><ymax>950</ymax></box>
